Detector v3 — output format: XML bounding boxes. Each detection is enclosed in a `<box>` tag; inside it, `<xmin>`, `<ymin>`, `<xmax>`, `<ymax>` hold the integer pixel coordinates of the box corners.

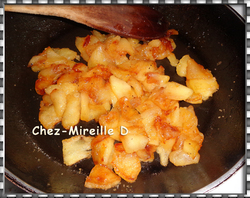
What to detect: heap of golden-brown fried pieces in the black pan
<box><xmin>29</xmin><ymin>30</ymin><xmax>219</xmax><ymax>189</ymax></box>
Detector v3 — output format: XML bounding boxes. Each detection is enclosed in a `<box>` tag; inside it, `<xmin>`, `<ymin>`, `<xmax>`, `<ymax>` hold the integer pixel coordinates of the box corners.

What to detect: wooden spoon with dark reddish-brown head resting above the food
<box><xmin>5</xmin><ymin>5</ymin><xmax>168</xmax><ymax>40</ymax></box>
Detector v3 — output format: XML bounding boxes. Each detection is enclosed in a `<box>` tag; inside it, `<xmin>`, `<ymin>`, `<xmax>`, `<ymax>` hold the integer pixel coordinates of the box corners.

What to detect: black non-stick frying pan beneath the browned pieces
<box><xmin>5</xmin><ymin>5</ymin><xmax>245</xmax><ymax>193</ymax></box>
